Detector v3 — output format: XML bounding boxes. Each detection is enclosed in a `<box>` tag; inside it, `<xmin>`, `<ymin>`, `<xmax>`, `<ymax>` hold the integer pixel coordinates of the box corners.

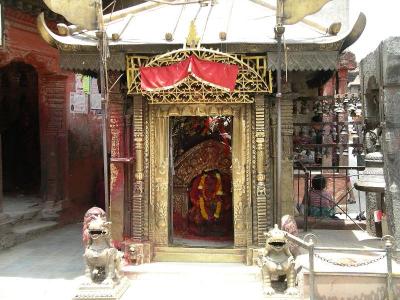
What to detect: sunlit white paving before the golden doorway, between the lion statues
<box><xmin>123</xmin><ymin>262</ymin><xmax>303</xmax><ymax>300</ymax></box>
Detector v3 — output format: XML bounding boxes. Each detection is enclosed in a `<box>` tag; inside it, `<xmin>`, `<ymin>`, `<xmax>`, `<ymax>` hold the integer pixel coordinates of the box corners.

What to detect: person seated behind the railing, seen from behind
<box><xmin>308</xmin><ymin>175</ymin><xmax>335</xmax><ymax>218</ymax></box>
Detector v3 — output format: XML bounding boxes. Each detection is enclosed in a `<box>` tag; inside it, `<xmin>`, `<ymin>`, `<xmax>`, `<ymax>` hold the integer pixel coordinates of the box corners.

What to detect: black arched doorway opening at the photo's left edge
<box><xmin>0</xmin><ymin>62</ymin><xmax>41</xmax><ymax>196</ymax></box>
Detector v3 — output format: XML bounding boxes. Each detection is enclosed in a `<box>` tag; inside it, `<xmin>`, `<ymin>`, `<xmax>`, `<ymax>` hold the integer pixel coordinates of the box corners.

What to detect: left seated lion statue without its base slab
<box><xmin>83</xmin><ymin>217</ymin><xmax>123</xmax><ymax>284</ymax></box>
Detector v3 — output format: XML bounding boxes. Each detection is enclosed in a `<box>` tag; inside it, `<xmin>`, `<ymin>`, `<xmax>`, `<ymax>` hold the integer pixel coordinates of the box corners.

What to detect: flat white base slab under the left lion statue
<box><xmin>73</xmin><ymin>277</ymin><xmax>130</xmax><ymax>300</ymax></box>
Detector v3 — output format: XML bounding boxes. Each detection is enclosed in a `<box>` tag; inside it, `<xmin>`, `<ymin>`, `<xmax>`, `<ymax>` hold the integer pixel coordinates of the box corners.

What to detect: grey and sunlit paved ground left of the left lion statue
<box><xmin>0</xmin><ymin>224</ymin><xmax>84</xmax><ymax>300</ymax></box>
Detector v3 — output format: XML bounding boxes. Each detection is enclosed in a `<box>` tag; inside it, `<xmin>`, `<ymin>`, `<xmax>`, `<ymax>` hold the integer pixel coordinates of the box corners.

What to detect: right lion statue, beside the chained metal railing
<box><xmin>258</xmin><ymin>224</ymin><xmax>298</xmax><ymax>295</ymax></box>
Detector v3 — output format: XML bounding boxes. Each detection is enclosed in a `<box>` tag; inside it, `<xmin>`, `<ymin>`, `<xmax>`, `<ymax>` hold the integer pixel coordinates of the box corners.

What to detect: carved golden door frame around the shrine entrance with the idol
<box><xmin>149</xmin><ymin>103</ymin><xmax>252</xmax><ymax>247</ymax></box>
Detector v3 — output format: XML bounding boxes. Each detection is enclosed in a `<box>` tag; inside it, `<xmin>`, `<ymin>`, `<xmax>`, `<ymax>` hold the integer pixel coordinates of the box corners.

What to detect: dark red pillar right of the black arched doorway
<box><xmin>38</xmin><ymin>73</ymin><xmax>73</xmax><ymax>217</ymax></box>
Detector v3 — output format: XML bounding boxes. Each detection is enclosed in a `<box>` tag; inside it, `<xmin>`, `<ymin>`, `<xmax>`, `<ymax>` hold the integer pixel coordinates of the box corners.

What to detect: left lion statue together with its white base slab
<box><xmin>74</xmin><ymin>210</ymin><xmax>129</xmax><ymax>300</ymax></box>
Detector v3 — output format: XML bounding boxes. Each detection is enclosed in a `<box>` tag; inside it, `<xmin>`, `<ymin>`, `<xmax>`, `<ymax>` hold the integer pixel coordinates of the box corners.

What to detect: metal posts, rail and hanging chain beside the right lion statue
<box><xmin>285</xmin><ymin>232</ymin><xmax>400</xmax><ymax>300</ymax></box>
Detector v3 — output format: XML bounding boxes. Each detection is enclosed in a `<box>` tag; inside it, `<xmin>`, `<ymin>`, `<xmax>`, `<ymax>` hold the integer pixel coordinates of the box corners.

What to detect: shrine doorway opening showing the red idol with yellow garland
<box><xmin>170</xmin><ymin>116</ymin><xmax>233</xmax><ymax>248</ymax></box>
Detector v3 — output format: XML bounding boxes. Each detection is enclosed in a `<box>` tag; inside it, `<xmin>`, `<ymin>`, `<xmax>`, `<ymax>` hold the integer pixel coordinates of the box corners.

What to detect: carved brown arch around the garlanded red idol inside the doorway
<box><xmin>173</xmin><ymin>140</ymin><xmax>232</xmax><ymax>229</ymax></box>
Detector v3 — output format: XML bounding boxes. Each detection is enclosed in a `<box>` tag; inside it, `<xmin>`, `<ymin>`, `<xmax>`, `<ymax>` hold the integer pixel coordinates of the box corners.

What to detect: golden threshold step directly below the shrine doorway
<box><xmin>153</xmin><ymin>247</ymin><xmax>246</xmax><ymax>263</ymax></box>
